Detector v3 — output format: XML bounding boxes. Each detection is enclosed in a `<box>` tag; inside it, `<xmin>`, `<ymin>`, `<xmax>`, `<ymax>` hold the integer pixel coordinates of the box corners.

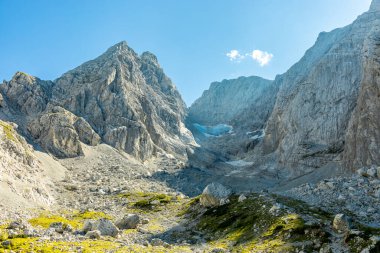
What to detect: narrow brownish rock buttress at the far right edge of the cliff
<box><xmin>344</xmin><ymin>19</ymin><xmax>380</xmax><ymax>168</ymax></box>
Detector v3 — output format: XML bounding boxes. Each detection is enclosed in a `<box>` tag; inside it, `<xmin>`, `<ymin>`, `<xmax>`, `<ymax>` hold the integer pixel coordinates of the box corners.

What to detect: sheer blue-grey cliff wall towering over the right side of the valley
<box><xmin>264</xmin><ymin>5</ymin><xmax>380</xmax><ymax>173</ymax></box>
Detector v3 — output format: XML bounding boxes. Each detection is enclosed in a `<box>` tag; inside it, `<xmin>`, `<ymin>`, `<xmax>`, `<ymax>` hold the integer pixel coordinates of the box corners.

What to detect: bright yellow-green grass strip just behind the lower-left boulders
<box><xmin>29</xmin><ymin>211</ymin><xmax>112</xmax><ymax>229</ymax></box>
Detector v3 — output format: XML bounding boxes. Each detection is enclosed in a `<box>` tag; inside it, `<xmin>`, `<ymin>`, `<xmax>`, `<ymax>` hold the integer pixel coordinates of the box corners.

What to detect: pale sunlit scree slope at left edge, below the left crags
<box><xmin>0</xmin><ymin>120</ymin><xmax>64</xmax><ymax>216</ymax></box>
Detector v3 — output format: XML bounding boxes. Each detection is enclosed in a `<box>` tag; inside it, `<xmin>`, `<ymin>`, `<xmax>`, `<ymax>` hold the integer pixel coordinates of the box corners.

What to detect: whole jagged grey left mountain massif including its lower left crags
<box><xmin>0</xmin><ymin>42</ymin><xmax>193</xmax><ymax>160</ymax></box>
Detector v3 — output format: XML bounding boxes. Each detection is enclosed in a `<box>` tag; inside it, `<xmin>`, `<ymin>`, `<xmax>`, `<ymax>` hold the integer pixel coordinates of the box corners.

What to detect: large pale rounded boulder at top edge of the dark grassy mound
<box><xmin>199</xmin><ymin>183</ymin><xmax>232</xmax><ymax>207</ymax></box>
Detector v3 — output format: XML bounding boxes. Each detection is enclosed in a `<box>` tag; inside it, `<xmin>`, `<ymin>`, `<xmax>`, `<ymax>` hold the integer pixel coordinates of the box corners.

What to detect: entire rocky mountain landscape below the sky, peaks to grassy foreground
<box><xmin>0</xmin><ymin>0</ymin><xmax>380</xmax><ymax>253</ymax></box>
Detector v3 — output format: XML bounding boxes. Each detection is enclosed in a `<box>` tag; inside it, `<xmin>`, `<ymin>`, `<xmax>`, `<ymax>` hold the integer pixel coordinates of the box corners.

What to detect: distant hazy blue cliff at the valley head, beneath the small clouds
<box><xmin>189</xmin><ymin>76</ymin><xmax>278</xmax><ymax>128</ymax></box>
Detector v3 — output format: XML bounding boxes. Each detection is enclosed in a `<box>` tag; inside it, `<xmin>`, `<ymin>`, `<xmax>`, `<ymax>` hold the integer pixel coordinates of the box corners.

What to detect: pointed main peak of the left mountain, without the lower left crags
<box><xmin>53</xmin><ymin>42</ymin><xmax>193</xmax><ymax>160</ymax></box>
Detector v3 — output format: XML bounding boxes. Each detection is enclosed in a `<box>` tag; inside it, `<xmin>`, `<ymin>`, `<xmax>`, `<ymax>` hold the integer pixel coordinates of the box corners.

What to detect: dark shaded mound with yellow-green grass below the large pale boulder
<box><xmin>184</xmin><ymin>194</ymin><xmax>326</xmax><ymax>252</ymax></box>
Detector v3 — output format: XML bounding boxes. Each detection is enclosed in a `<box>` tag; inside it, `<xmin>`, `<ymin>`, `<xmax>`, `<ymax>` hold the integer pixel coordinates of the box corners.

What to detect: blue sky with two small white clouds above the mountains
<box><xmin>0</xmin><ymin>0</ymin><xmax>371</xmax><ymax>105</ymax></box>
